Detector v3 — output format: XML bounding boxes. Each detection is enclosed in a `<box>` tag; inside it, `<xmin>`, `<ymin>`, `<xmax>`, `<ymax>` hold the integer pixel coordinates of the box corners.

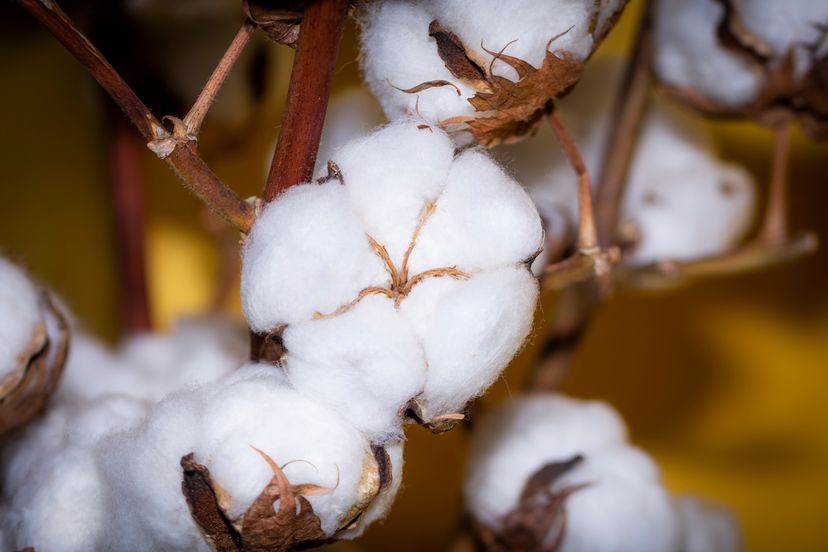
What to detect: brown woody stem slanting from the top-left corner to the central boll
<box><xmin>19</xmin><ymin>0</ymin><xmax>255</xmax><ymax>232</ymax></box>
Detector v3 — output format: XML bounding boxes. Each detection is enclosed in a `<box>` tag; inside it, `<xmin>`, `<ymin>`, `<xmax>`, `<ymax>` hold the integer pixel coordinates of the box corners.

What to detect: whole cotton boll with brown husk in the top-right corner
<box><xmin>654</xmin><ymin>0</ymin><xmax>828</xmax><ymax>138</ymax></box>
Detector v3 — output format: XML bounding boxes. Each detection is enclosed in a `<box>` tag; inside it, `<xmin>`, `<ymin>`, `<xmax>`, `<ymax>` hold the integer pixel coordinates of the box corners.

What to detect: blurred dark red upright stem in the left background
<box><xmin>110</xmin><ymin>116</ymin><xmax>151</xmax><ymax>332</ymax></box>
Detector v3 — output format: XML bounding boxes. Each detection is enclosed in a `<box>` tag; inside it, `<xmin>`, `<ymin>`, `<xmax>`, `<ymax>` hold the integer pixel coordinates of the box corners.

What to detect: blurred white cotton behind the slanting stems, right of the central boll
<box><xmin>497</xmin><ymin>59</ymin><xmax>755</xmax><ymax>270</ymax></box>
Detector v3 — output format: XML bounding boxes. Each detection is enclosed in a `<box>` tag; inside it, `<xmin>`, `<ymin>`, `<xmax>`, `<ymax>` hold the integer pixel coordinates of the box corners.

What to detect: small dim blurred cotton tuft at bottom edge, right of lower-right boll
<box><xmin>673</xmin><ymin>495</ymin><xmax>743</xmax><ymax>552</ymax></box>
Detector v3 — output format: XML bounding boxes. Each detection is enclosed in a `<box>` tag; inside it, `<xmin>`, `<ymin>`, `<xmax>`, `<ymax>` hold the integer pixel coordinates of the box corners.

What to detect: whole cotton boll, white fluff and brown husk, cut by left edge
<box><xmin>0</xmin><ymin>258</ymin><xmax>69</xmax><ymax>435</ymax></box>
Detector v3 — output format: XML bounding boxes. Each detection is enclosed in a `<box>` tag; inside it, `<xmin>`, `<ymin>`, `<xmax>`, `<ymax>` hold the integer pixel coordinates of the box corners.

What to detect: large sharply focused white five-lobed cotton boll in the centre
<box><xmin>242</xmin><ymin>122</ymin><xmax>542</xmax><ymax>430</ymax></box>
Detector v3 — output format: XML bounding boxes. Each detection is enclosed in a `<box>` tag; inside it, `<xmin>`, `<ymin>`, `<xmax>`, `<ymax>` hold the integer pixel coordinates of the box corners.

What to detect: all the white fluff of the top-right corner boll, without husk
<box><xmin>654</xmin><ymin>0</ymin><xmax>828</xmax><ymax>107</ymax></box>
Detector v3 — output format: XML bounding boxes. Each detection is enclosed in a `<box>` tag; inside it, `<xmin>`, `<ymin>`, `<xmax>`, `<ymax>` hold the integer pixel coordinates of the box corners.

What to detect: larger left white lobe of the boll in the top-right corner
<box><xmin>654</xmin><ymin>0</ymin><xmax>762</xmax><ymax>106</ymax></box>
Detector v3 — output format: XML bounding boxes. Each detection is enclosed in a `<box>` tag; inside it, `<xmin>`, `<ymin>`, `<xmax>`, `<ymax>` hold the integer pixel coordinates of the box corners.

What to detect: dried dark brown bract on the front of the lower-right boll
<box><xmin>472</xmin><ymin>455</ymin><xmax>586</xmax><ymax>552</ymax></box>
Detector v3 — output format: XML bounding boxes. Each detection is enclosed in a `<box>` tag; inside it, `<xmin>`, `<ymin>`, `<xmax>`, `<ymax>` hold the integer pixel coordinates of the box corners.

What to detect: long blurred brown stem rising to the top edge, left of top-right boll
<box><xmin>595</xmin><ymin>3</ymin><xmax>653</xmax><ymax>246</ymax></box>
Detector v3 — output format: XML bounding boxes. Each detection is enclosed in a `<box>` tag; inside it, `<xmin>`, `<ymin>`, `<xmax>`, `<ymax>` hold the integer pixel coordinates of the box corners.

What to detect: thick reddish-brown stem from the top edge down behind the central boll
<box><xmin>263</xmin><ymin>0</ymin><xmax>348</xmax><ymax>202</ymax></box>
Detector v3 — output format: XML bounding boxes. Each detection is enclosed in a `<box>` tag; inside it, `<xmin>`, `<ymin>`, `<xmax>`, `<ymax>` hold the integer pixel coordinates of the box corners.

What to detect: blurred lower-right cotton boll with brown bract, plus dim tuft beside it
<box><xmin>464</xmin><ymin>394</ymin><xmax>738</xmax><ymax>552</ymax></box>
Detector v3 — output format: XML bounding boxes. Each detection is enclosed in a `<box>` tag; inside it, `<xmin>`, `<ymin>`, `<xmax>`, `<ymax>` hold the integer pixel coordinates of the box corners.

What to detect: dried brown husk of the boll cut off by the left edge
<box><xmin>0</xmin><ymin>291</ymin><xmax>69</xmax><ymax>435</ymax></box>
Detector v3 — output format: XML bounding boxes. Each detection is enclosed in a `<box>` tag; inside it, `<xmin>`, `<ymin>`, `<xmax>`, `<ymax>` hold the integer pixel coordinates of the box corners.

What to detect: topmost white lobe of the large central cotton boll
<box><xmin>333</xmin><ymin>121</ymin><xmax>456</xmax><ymax>266</ymax></box>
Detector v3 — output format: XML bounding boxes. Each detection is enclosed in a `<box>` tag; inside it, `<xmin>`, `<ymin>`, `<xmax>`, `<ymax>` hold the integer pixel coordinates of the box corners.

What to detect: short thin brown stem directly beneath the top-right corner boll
<box><xmin>759</xmin><ymin>122</ymin><xmax>791</xmax><ymax>244</ymax></box>
